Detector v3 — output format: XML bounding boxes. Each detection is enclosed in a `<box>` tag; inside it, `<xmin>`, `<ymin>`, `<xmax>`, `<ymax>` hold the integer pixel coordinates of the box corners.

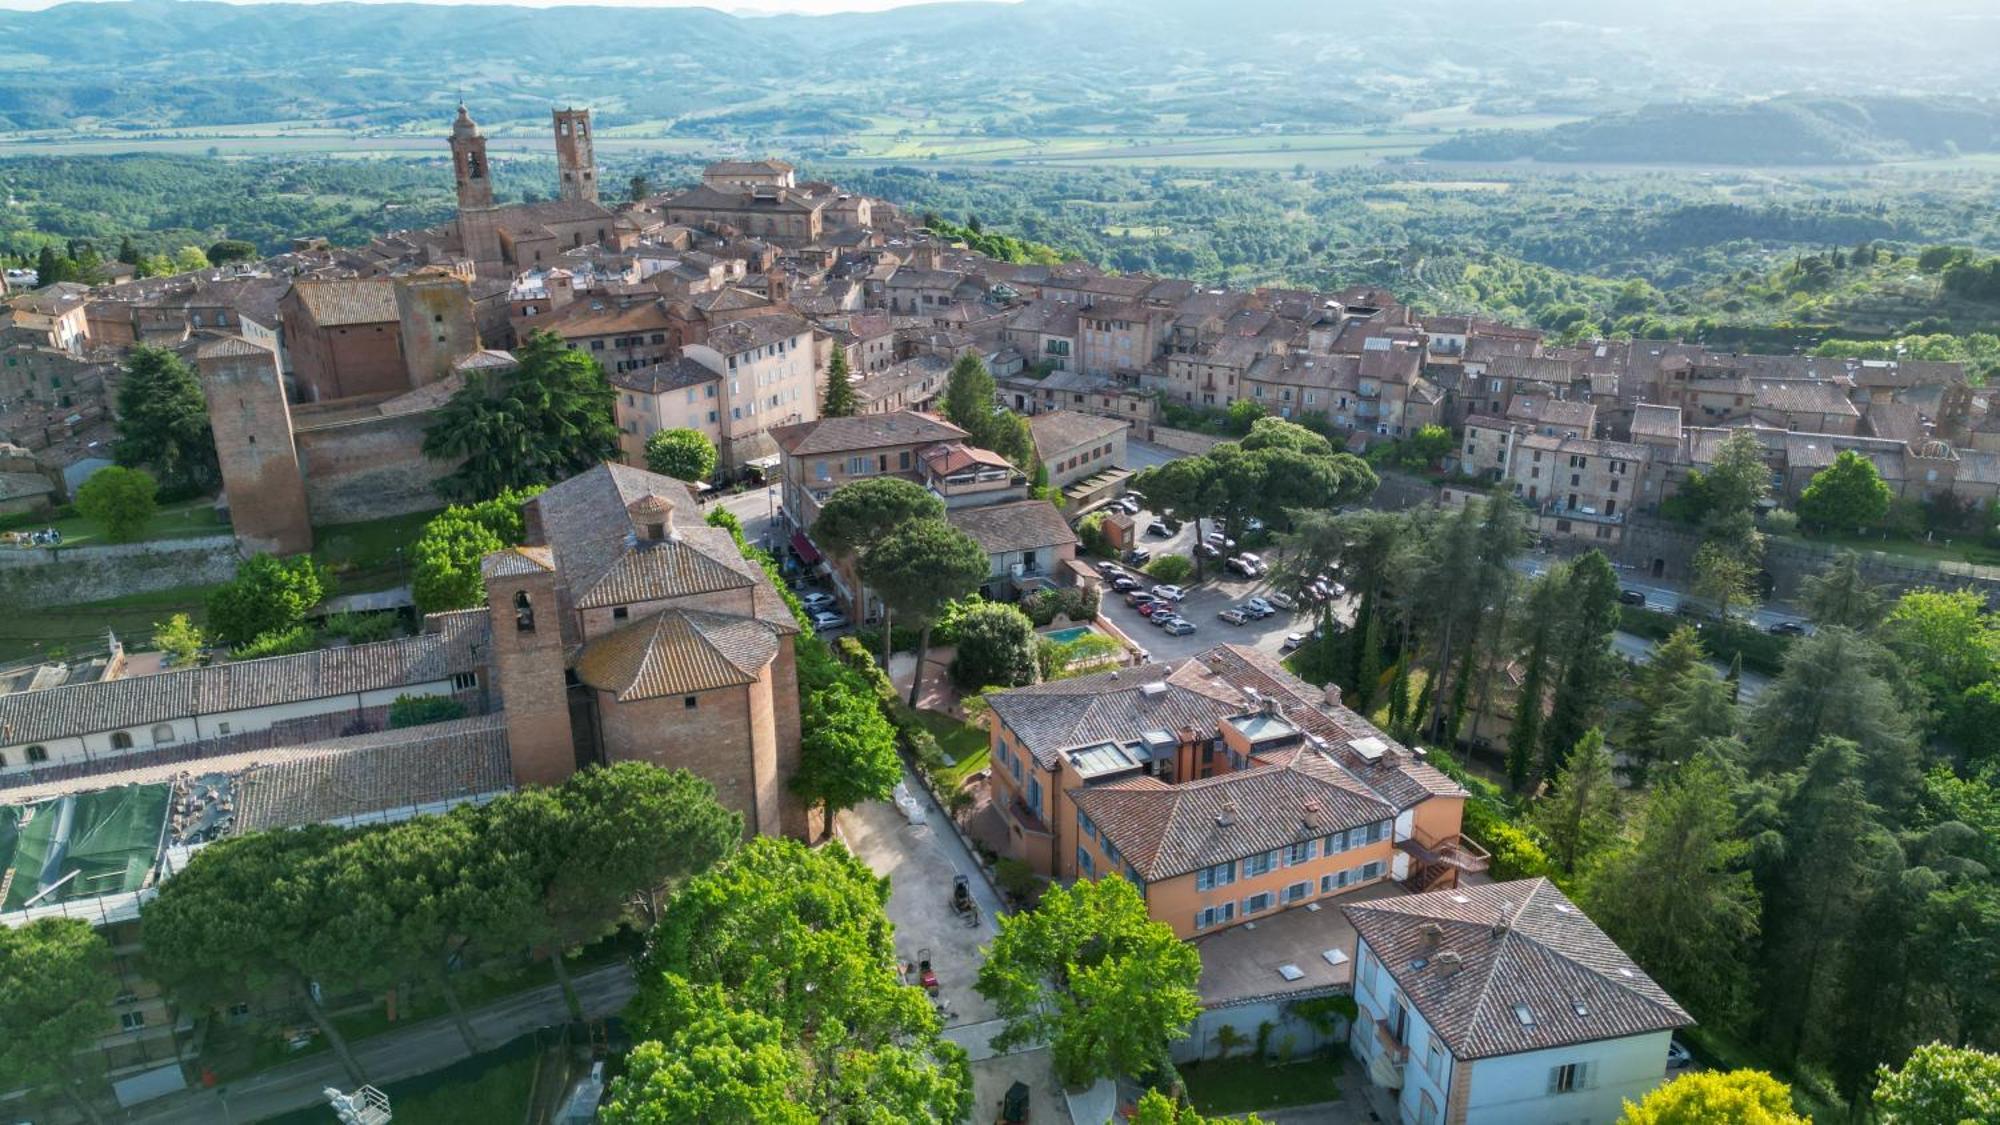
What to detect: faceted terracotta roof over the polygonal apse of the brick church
<box><xmin>576</xmin><ymin>609</ymin><xmax>778</xmax><ymax>703</ymax></box>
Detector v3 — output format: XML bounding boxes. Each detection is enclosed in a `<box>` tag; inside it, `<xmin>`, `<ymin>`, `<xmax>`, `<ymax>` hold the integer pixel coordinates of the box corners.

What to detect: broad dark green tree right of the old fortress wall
<box><xmin>424</xmin><ymin>332</ymin><xmax>618</xmax><ymax>500</ymax></box>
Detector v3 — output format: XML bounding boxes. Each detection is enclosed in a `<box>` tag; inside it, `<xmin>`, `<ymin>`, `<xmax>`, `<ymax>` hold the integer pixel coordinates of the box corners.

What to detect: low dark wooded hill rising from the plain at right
<box><xmin>1424</xmin><ymin>96</ymin><xmax>2000</xmax><ymax>166</ymax></box>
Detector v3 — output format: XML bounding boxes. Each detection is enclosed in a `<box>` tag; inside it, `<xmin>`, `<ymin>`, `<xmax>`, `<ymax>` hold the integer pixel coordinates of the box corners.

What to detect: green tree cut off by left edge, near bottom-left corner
<box><xmin>0</xmin><ymin>917</ymin><xmax>118</xmax><ymax>1121</ymax></box>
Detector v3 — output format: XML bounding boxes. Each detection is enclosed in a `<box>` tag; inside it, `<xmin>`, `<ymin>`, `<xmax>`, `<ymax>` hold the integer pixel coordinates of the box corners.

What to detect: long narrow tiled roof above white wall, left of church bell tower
<box><xmin>0</xmin><ymin>611</ymin><xmax>488</xmax><ymax>745</ymax></box>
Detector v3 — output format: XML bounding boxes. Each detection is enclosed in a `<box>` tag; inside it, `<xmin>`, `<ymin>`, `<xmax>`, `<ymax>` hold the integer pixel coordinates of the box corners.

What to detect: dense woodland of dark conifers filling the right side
<box><xmin>1280</xmin><ymin>486</ymin><xmax>2000</xmax><ymax>1109</ymax></box>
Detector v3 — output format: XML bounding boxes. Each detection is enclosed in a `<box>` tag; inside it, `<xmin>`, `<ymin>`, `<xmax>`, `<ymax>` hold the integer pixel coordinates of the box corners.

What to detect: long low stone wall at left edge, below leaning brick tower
<box><xmin>0</xmin><ymin>534</ymin><xmax>238</xmax><ymax>607</ymax></box>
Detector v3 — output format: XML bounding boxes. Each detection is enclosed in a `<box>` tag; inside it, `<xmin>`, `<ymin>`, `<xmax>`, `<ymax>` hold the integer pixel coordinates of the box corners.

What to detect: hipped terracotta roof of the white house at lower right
<box><xmin>1340</xmin><ymin>879</ymin><xmax>1694</xmax><ymax>1059</ymax></box>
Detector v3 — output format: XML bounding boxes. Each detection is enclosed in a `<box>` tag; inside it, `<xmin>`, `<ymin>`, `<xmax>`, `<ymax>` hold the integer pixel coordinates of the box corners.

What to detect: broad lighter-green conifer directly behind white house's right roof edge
<box><xmin>1584</xmin><ymin>755</ymin><xmax>1760</xmax><ymax>1027</ymax></box>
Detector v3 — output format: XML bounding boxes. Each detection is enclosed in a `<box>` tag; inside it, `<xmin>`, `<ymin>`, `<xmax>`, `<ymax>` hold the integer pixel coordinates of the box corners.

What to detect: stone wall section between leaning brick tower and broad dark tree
<box><xmin>294</xmin><ymin>410</ymin><xmax>452</xmax><ymax>526</ymax></box>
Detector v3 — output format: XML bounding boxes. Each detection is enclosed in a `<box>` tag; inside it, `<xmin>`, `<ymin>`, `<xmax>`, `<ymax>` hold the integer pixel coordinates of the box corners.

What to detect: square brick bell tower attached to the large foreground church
<box><xmin>480</xmin><ymin>546</ymin><xmax>576</xmax><ymax>785</ymax></box>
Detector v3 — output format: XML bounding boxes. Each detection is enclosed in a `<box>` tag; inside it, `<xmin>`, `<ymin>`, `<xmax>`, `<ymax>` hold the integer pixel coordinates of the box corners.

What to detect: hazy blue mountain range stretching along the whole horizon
<box><xmin>0</xmin><ymin>0</ymin><xmax>2000</xmax><ymax>133</ymax></box>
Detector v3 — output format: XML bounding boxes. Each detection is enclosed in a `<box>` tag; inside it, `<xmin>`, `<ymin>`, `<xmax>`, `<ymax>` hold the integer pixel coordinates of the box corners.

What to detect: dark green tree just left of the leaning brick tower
<box><xmin>112</xmin><ymin>344</ymin><xmax>222</xmax><ymax>496</ymax></box>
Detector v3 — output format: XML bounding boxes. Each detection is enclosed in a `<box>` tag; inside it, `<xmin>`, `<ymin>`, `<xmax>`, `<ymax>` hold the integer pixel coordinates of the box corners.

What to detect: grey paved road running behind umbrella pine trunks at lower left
<box><xmin>126</xmin><ymin>963</ymin><xmax>636</xmax><ymax>1125</ymax></box>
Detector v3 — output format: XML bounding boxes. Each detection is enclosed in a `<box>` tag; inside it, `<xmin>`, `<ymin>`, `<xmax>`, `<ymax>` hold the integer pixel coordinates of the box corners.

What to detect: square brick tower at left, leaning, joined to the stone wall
<box><xmin>194</xmin><ymin>334</ymin><xmax>312</xmax><ymax>554</ymax></box>
